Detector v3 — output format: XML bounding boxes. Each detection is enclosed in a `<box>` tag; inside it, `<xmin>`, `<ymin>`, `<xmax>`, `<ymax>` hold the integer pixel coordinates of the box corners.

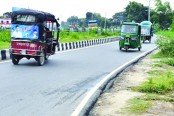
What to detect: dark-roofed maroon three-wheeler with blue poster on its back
<box><xmin>10</xmin><ymin>9</ymin><xmax>59</xmax><ymax>66</ymax></box>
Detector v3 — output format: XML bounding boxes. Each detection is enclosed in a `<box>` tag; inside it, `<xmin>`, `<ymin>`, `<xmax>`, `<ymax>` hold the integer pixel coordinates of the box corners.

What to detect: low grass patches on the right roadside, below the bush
<box><xmin>122</xmin><ymin>52</ymin><xmax>174</xmax><ymax>115</ymax></box>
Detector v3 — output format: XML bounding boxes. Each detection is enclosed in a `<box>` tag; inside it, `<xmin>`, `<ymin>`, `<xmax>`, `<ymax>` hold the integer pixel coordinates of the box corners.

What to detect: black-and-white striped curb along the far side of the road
<box><xmin>0</xmin><ymin>37</ymin><xmax>119</xmax><ymax>61</ymax></box>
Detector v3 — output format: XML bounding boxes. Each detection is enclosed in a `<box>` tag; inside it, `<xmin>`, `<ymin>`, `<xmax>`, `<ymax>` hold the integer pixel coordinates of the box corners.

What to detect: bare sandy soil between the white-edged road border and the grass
<box><xmin>89</xmin><ymin>51</ymin><xmax>174</xmax><ymax>116</ymax></box>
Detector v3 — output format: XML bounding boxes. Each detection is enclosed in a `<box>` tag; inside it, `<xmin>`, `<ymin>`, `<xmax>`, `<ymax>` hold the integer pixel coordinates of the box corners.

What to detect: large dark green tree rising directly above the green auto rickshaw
<box><xmin>125</xmin><ymin>1</ymin><xmax>148</xmax><ymax>23</ymax></box>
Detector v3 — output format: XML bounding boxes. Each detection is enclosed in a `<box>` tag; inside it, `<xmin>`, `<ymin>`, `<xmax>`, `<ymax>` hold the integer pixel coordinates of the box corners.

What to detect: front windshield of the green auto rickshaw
<box><xmin>121</xmin><ymin>25</ymin><xmax>137</xmax><ymax>33</ymax></box>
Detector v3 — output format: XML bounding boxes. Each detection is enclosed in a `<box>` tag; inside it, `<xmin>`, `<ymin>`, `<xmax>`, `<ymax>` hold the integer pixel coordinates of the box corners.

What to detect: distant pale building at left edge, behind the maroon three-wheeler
<box><xmin>0</xmin><ymin>18</ymin><xmax>11</xmax><ymax>28</ymax></box>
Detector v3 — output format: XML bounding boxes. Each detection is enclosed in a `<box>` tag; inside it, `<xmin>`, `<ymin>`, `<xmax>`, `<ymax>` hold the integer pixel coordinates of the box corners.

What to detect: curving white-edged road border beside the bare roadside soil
<box><xmin>71</xmin><ymin>47</ymin><xmax>157</xmax><ymax>116</ymax></box>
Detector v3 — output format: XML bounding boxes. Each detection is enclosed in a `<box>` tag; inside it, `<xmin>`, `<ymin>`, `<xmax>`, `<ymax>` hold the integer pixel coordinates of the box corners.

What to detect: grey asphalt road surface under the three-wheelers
<box><xmin>0</xmin><ymin>37</ymin><xmax>155</xmax><ymax>116</ymax></box>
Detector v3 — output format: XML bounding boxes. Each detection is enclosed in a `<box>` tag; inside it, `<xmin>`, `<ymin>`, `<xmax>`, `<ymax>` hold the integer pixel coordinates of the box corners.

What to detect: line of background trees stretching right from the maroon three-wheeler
<box><xmin>61</xmin><ymin>0</ymin><xmax>174</xmax><ymax>30</ymax></box>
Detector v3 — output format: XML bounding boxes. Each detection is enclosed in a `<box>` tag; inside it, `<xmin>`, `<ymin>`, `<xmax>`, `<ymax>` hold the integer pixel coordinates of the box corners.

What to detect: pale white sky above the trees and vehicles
<box><xmin>0</xmin><ymin>0</ymin><xmax>174</xmax><ymax>21</ymax></box>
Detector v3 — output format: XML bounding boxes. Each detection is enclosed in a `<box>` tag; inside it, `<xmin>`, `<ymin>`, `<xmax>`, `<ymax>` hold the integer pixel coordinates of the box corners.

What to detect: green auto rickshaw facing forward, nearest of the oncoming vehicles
<box><xmin>119</xmin><ymin>22</ymin><xmax>141</xmax><ymax>52</ymax></box>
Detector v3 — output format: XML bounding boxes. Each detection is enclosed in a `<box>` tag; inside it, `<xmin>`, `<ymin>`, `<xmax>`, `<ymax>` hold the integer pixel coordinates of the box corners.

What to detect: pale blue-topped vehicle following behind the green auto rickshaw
<box><xmin>140</xmin><ymin>21</ymin><xmax>153</xmax><ymax>43</ymax></box>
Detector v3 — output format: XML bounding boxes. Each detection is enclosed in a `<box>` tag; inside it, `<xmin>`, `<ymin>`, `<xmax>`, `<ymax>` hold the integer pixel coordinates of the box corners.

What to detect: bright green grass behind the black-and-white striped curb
<box><xmin>0</xmin><ymin>30</ymin><xmax>120</xmax><ymax>49</ymax></box>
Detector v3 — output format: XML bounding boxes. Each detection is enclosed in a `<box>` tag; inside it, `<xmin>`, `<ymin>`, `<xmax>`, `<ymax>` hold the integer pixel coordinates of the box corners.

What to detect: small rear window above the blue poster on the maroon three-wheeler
<box><xmin>13</xmin><ymin>15</ymin><xmax>36</xmax><ymax>23</ymax></box>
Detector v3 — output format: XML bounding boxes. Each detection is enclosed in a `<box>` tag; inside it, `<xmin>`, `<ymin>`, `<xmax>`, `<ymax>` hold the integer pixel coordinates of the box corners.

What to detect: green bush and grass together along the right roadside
<box><xmin>123</xmin><ymin>31</ymin><xmax>174</xmax><ymax>115</ymax></box>
